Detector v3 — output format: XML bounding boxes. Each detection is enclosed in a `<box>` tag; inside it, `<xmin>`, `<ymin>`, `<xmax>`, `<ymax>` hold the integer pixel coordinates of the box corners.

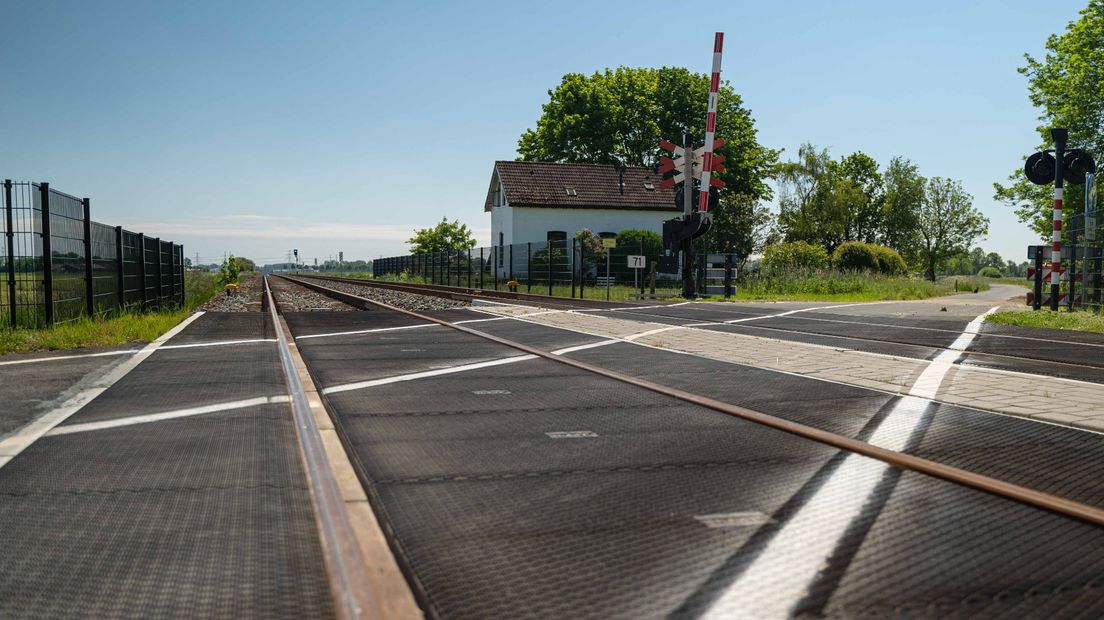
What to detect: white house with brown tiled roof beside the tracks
<box><xmin>484</xmin><ymin>161</ymin><xmax>681</xmax><ymax>273</ymax></box>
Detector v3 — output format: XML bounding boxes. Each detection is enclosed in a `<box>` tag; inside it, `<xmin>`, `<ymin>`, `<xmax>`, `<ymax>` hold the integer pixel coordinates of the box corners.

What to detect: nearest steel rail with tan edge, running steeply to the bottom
<box><xmin>263</xmin><ymin>277</ymin><xmax>381</xmax><ymax>619</ymax></box>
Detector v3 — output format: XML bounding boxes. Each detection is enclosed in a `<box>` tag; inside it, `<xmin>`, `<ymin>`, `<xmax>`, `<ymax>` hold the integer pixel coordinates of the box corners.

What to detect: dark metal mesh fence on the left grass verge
<box><xmin>0</xmin><ymin>180</ymin><xmax>184</xmax><ymax>328</ymax></box>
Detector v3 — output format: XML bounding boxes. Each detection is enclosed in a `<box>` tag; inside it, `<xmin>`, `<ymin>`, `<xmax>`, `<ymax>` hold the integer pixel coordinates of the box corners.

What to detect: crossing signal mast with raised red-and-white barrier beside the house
<box><xmin>659</xmin><ymin>32</ymin><xmax>724</xmax><ymax>299</ymax></box>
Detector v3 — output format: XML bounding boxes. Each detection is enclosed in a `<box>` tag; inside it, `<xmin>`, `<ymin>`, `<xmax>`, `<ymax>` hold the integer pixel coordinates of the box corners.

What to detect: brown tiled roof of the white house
<box><xmin>485</xmin><ymin>161</ymin><xmax>679</xmax><ymax>212</ymax></box>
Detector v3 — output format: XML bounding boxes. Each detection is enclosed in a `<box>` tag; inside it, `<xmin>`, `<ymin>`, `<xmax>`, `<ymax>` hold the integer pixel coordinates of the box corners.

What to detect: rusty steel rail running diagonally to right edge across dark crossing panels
<box><xmin>288</xmin><ymin>273</ymin><xmax>1104</xmax><ymax>526</ymax></box>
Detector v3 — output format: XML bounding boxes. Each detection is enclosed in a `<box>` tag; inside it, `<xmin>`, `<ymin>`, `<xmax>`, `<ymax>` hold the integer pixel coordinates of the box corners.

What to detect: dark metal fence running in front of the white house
<box><xmin>372</xmin><ymin>233</ymin><xmax>682</xmax><ymax>300</ymax></box>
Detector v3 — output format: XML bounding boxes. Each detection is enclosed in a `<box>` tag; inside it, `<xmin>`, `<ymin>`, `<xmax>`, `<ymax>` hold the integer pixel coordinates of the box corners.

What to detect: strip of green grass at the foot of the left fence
<box><xmin>0</xmin><ymin>271</ymin><xmax>219</xmax><ymax>355</ymax></box>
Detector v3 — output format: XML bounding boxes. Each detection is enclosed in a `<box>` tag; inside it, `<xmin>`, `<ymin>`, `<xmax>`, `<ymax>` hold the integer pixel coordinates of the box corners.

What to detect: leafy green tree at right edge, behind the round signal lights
<box><xmin>992</xmin><ymin>0</ymin><xmax>1104</xmax><ymax>240</ymax></box>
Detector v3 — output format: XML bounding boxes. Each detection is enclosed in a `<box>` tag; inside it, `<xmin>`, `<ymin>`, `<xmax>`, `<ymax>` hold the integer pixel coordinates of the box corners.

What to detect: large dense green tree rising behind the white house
<box><xmin>518</xmin><ymin>66</ymin><xmax>779</xmax><ymax>200</ymax></box>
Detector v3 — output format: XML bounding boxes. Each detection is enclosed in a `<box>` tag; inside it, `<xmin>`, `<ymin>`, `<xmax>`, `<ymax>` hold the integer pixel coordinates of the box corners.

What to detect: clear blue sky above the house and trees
<box><xmin>0</xmin><ymin>0</ymin><xmax>1085</xmax><ymax>263</ymax></box>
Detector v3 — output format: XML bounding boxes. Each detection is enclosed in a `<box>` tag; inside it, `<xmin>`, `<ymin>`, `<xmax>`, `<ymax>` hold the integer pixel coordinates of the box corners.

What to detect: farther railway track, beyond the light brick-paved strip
<box><xmin>295</xmin><ymin>276</ymin><xmax>1104</xmax><ymax>383</ymax></box>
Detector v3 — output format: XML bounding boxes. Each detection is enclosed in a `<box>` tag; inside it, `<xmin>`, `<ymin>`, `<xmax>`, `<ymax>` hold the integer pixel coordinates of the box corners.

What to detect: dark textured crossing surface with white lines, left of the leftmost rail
<box><xmin>0</xmin><ymin>313</ymin><xmax>333</xmax><ymax>618</ymax></box>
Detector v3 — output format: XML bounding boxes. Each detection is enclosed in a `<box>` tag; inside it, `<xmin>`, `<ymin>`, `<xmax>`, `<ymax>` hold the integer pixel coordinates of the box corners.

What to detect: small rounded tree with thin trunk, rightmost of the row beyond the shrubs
<box><xmin>917</xmin><ymin>177</ymin><xmax>989</xmax><ymax>281</ymax></box>
